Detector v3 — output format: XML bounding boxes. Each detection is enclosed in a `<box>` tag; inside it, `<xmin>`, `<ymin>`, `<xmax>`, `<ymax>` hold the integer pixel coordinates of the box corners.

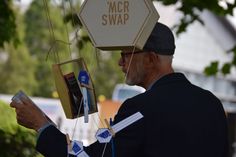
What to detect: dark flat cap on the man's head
<box><xmin>143</xmin><ymin>22</ymin><xmax>175</xmax><ymax>55</ymax></box>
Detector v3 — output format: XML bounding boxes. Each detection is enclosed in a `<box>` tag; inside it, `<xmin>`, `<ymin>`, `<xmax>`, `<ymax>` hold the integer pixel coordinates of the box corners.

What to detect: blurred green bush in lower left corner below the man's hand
<box><xmin>0</xmin><ymin>101</ymin><xmax>41</xmax><ymax>157</ymax></box>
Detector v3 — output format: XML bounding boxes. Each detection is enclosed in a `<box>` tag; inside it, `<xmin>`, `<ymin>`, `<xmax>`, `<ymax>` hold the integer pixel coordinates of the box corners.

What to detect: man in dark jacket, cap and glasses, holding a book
<box><xmin>11</xmin><ymin>23</ymin><xmax>228</xmax><ymax>157</ymax></box>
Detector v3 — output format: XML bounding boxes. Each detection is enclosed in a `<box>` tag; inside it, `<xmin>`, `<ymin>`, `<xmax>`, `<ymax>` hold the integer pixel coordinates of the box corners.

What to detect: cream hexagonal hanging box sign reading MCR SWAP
<box><xmin>79</xmin><ymin>0</ymin><xmax>159</xmax><ymax>50</ymax></box>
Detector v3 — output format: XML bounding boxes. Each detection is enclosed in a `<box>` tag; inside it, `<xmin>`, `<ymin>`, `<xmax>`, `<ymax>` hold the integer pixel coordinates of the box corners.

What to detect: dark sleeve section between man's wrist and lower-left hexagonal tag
<box><xmin>36</xmin><ymin>125</ymin><xmax>67</xmax><ymax>157</ymax></box>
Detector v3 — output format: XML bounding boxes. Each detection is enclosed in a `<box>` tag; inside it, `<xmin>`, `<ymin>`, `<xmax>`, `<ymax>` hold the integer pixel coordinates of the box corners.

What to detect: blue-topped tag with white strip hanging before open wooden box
<box><xmin>78</xmin><ymin>70</ymin><xmax>89</xmax><ymax>123</ymax></box>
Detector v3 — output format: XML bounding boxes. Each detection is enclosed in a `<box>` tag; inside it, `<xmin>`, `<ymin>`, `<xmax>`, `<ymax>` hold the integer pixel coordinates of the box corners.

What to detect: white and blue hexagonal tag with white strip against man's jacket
<box><xmin>95</xmin><ymin>112</ymin><xmax>143</xmax><ymax>143</ymax></box>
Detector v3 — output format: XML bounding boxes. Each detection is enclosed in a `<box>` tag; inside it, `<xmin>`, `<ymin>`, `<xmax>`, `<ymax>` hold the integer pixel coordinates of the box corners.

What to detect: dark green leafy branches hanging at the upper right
<box><xmin>155</xmin><ymin>0</ymin><xmax>236</xmax><ymax>75</ymax></box>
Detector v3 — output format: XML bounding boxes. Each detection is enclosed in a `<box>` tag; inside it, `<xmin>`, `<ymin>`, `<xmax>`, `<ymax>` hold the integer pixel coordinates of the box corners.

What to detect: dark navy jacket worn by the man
<box><xmin>37</xmin><ymin>73</ymin><xmax>228</xmax><ymax>157</ymax></box>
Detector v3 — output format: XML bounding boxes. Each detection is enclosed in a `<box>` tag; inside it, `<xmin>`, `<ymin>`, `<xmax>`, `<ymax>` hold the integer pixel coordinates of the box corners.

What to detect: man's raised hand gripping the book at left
<box><xmin>10</xmin><ymin>98</ymin><xmax>49</xmax><ymax>131</ymax></box>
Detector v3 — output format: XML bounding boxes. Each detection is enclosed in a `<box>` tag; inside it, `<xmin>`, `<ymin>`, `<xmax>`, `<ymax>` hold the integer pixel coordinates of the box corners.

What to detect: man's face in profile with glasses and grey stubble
<box><xmin>119</xmin><ymin>51</ymin><xmax>145</xmax><ymax>86</ymax></box>
